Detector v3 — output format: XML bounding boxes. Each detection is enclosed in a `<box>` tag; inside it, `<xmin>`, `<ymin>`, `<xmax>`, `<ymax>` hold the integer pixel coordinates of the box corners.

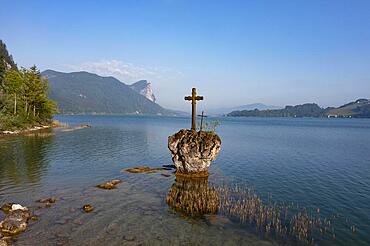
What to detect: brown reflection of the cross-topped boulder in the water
<box><xmin>166</xmin><ymin>177</ymin><xmax>219</xmax><ymax>216</ymax></box>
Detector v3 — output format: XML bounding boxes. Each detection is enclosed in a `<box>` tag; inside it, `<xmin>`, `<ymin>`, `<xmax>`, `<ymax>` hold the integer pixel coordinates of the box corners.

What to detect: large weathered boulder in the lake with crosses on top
<box><xmin>168</xmin><ymin>129</ymin><xmax>221</xmax><ymax>176</ymax></box>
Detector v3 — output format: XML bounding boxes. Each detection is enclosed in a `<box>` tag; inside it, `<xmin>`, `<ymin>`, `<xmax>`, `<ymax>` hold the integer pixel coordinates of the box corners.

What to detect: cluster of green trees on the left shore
<box><xmin>0</xmin><ymin>40</ymin><xmax>57</xmax><ymax>130</ymax></box>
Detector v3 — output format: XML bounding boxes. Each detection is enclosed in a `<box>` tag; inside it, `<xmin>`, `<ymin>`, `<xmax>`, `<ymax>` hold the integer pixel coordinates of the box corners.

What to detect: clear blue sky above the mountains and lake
<box><xmin>0</xmin><ymin>0</ymin><xmax>370</xmax><ymax>109</ymax></box>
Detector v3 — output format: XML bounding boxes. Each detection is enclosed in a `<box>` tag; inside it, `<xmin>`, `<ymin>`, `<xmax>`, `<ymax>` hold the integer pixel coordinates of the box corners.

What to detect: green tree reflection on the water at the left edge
<box><xmin>0</xmin><ymin>130</ymin><xmax>54</xmax><ymax>195</ymax></box>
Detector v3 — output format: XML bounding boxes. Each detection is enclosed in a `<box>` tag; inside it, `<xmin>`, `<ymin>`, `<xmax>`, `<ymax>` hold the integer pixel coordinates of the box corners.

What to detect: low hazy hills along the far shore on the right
<box><xmin>227</xmin><ymin>99</ymin><xmax>370</xmax><ymax>118</ymax></box>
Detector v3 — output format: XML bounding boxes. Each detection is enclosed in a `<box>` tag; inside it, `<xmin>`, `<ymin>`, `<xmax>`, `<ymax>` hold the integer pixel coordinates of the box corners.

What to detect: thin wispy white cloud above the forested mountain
<box><xmin>67</xmin><ymin>60</ymin><xmax>181</xmax><ymax>83</ymax></box>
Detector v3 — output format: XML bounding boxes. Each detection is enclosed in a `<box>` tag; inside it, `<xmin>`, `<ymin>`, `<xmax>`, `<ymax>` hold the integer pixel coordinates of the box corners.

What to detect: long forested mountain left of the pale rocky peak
<box><xmin>42</xmin><ymin>70</ymin><xmax>175</xmax><ymax>115</ymax></box>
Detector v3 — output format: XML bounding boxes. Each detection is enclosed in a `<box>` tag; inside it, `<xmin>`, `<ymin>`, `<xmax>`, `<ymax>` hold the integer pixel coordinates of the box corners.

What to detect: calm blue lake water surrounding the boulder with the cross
<box><xmin>0</xmin><ymin>116</ymin><xmax>370</xmax><ymax>245</ymax></box>
